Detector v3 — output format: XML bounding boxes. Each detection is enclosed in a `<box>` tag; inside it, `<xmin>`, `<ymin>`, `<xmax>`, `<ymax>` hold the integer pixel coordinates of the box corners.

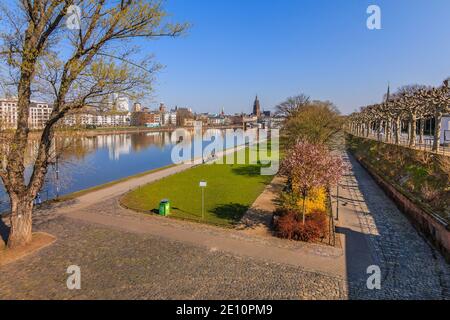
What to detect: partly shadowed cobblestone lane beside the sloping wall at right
<box><xmin>341</xmin><ymin>156</ymin><xmax>450</xmax><ymax>299</ymax></box>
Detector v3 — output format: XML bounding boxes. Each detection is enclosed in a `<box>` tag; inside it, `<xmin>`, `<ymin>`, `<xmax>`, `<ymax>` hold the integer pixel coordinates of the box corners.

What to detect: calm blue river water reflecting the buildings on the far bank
<box><xmin>0</xmin><ymin>130</ymin><xmax>232</xmax><ymax>212</ymax></box>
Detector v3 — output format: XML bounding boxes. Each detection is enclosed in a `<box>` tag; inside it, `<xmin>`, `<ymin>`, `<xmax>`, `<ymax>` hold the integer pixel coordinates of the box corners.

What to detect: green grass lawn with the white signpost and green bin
<box><xmin>121</xmin><ymin>146</ymin><xmax>273</xmax><ymax>227</ymax></box>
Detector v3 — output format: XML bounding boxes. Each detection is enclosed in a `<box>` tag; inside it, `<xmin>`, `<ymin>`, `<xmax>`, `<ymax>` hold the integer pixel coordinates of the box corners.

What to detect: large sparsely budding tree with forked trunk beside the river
<box><xmin>0</xmin><ymin>0</ymin><xmax>187</xmax><ymax>248</ymax></box>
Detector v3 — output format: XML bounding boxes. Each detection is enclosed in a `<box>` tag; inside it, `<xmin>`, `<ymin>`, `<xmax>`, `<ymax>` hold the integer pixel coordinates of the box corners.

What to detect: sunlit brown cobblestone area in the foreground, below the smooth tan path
<box><xmin>0</xmin><ymin>216</ymin><xmax>345</xmax><ymax>299</ymax></box>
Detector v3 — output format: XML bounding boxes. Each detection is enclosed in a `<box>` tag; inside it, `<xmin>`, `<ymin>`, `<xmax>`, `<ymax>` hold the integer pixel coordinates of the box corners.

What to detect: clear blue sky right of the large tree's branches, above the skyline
<box><xmin>145</xmin><ymin>0</ymin><xmax>450</xmax><ymax>113</ymax></box>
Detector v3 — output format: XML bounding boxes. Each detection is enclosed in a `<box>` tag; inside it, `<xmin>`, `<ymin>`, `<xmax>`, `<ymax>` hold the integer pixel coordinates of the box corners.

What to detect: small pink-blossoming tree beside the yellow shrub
<box><xmin>280</xmin><ymin>141</ymin><xmax>344</xmax><ymax>224</ymax></box>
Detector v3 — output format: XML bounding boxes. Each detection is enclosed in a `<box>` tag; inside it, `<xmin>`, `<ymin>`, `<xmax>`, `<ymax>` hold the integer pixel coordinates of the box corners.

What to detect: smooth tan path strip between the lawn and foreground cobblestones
<box><xmin>64</xmin><ymin>198</ymin><xmax>344</xmax><ymax>277</ymax></box>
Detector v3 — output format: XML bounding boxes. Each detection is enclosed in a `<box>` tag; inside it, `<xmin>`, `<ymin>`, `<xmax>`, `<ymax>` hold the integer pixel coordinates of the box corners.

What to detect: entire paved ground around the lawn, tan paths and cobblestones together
<box><xmin>0</xmin><ymin>146</ymin><xmax>450</xmax><ymax>299</ymax></box>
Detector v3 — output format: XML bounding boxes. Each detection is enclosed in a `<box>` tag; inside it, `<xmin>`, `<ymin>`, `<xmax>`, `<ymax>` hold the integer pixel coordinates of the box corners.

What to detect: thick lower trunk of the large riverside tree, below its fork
<box><xmin>7</xmin><ymin>196</ymin><xmax>33</xmax><ymax>249</ymax></box>
